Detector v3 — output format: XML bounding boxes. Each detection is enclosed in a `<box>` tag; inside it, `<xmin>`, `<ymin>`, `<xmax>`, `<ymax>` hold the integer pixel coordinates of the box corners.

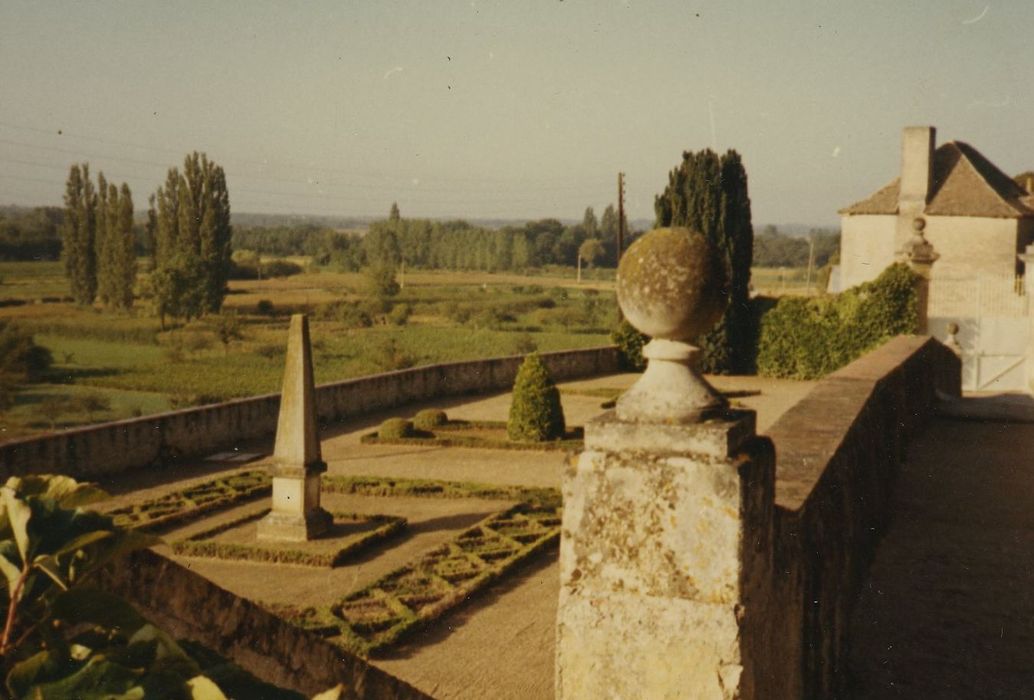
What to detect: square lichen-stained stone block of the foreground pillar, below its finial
<box><xmin>556</xmin><ymin>412</ymin><xmax>773</xmax><ymax>698</ymax></box>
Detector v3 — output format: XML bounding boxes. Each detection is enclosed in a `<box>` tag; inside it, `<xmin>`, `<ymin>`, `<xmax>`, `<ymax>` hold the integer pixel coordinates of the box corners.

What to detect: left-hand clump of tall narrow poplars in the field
<box><xmin>62</xmin><ymin>163</ymin><xmax>136</xmax><ymax>309</ymax></box>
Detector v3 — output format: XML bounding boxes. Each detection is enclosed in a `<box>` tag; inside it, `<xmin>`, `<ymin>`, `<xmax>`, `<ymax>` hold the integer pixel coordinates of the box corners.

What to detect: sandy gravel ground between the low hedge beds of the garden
<box><xmin>97</xmin><ymin>374</ymin><xmax>813</xmax><ymax>699</ymax></box>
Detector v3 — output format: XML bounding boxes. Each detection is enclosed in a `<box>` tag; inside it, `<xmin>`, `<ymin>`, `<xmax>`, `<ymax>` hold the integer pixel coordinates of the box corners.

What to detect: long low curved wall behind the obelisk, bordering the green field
<box><xmin>0</xmin><ymin>346</ymin><xmax>618</xmax><ymax>479</ymax></box>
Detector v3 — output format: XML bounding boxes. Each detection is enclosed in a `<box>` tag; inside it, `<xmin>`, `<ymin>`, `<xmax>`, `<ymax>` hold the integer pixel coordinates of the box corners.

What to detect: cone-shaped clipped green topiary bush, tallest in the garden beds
<box><xmin>507</xmin><ymin>353</ymin><xmax>565</xmax><ymax>442</ymax></box>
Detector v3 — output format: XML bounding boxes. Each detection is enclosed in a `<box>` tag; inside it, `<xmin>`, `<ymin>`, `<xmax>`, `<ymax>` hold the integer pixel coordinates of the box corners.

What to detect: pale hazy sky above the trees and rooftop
<box><xmin>0</xmin><ymin>0</ymin><xmax>1034</xmax><ymax>223</ymax></box>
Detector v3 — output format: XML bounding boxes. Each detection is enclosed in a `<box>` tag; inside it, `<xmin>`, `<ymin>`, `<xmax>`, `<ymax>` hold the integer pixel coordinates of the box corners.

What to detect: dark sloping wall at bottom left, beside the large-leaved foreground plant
<box><xmin>102</xmin><ymin>550</ymin><xmax>430</xmax><ymax>700</ymax></box>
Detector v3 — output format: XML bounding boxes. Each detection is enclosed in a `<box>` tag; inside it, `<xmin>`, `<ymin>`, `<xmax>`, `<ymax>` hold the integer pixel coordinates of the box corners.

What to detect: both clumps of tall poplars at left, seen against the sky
<box><xmin>61</xmin><ymin>152</ymin><xmax>233</xmax><ymax>325</ymax></box>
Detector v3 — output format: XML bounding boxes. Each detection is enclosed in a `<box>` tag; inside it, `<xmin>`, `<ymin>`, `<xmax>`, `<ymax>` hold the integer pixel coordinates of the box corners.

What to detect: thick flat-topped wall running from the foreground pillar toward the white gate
<box><xmin>759</xmin><ymin>336</ymin><xmax>962</xmax><ymax>698</ymax></box>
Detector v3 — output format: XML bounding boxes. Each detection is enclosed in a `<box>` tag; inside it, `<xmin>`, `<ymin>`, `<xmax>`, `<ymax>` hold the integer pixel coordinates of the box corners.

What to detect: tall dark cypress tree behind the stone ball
<box><xmin>653</xmin><ymin>149</ymin><xmax>754</xmax><ymax>373</ymax></box>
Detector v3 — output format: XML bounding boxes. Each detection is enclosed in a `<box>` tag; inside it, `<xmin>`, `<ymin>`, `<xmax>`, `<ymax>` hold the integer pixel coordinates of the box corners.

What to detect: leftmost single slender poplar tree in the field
<box><xmin>61</xmin><ymin>163</ymin><xmax>97</xmax><ymax>305</ymax></box>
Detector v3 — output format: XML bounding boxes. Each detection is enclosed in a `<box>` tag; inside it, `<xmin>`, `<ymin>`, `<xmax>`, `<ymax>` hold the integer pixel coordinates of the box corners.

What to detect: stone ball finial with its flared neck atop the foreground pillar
<box><xmin>616</xmin><ymin>227</ymin><xmax>729</xmax><ymax>423</ymax></box>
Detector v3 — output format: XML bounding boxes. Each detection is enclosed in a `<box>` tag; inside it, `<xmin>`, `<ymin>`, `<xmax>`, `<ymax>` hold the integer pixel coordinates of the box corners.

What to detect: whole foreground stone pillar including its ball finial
<box><xmin>556</xmin><ymin>229</ymin><xmax>777</xmax><ymax>699</ymax></box>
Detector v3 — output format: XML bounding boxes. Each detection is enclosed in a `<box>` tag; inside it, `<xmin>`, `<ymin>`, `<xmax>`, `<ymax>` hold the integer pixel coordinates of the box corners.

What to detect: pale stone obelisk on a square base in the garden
<box><xmin>259</xmin><ymin>313</ymin><xmax>333</xmax><ymax>542</ymax></box>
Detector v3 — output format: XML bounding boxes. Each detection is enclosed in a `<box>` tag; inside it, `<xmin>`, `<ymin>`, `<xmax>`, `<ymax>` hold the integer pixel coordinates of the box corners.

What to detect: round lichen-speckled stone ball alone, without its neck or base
<box><xmin>617</xmin><ymin>227</ymin><xmax>729</xmax><ymax>341</ymax></box>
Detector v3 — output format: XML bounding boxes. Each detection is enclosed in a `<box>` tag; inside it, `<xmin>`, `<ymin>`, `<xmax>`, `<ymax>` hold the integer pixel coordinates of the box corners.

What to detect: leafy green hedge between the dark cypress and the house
<box><xmin>758</xmin><ymin>263</ymin><xmax>918</xmax><ymax>379</ymax></box>
